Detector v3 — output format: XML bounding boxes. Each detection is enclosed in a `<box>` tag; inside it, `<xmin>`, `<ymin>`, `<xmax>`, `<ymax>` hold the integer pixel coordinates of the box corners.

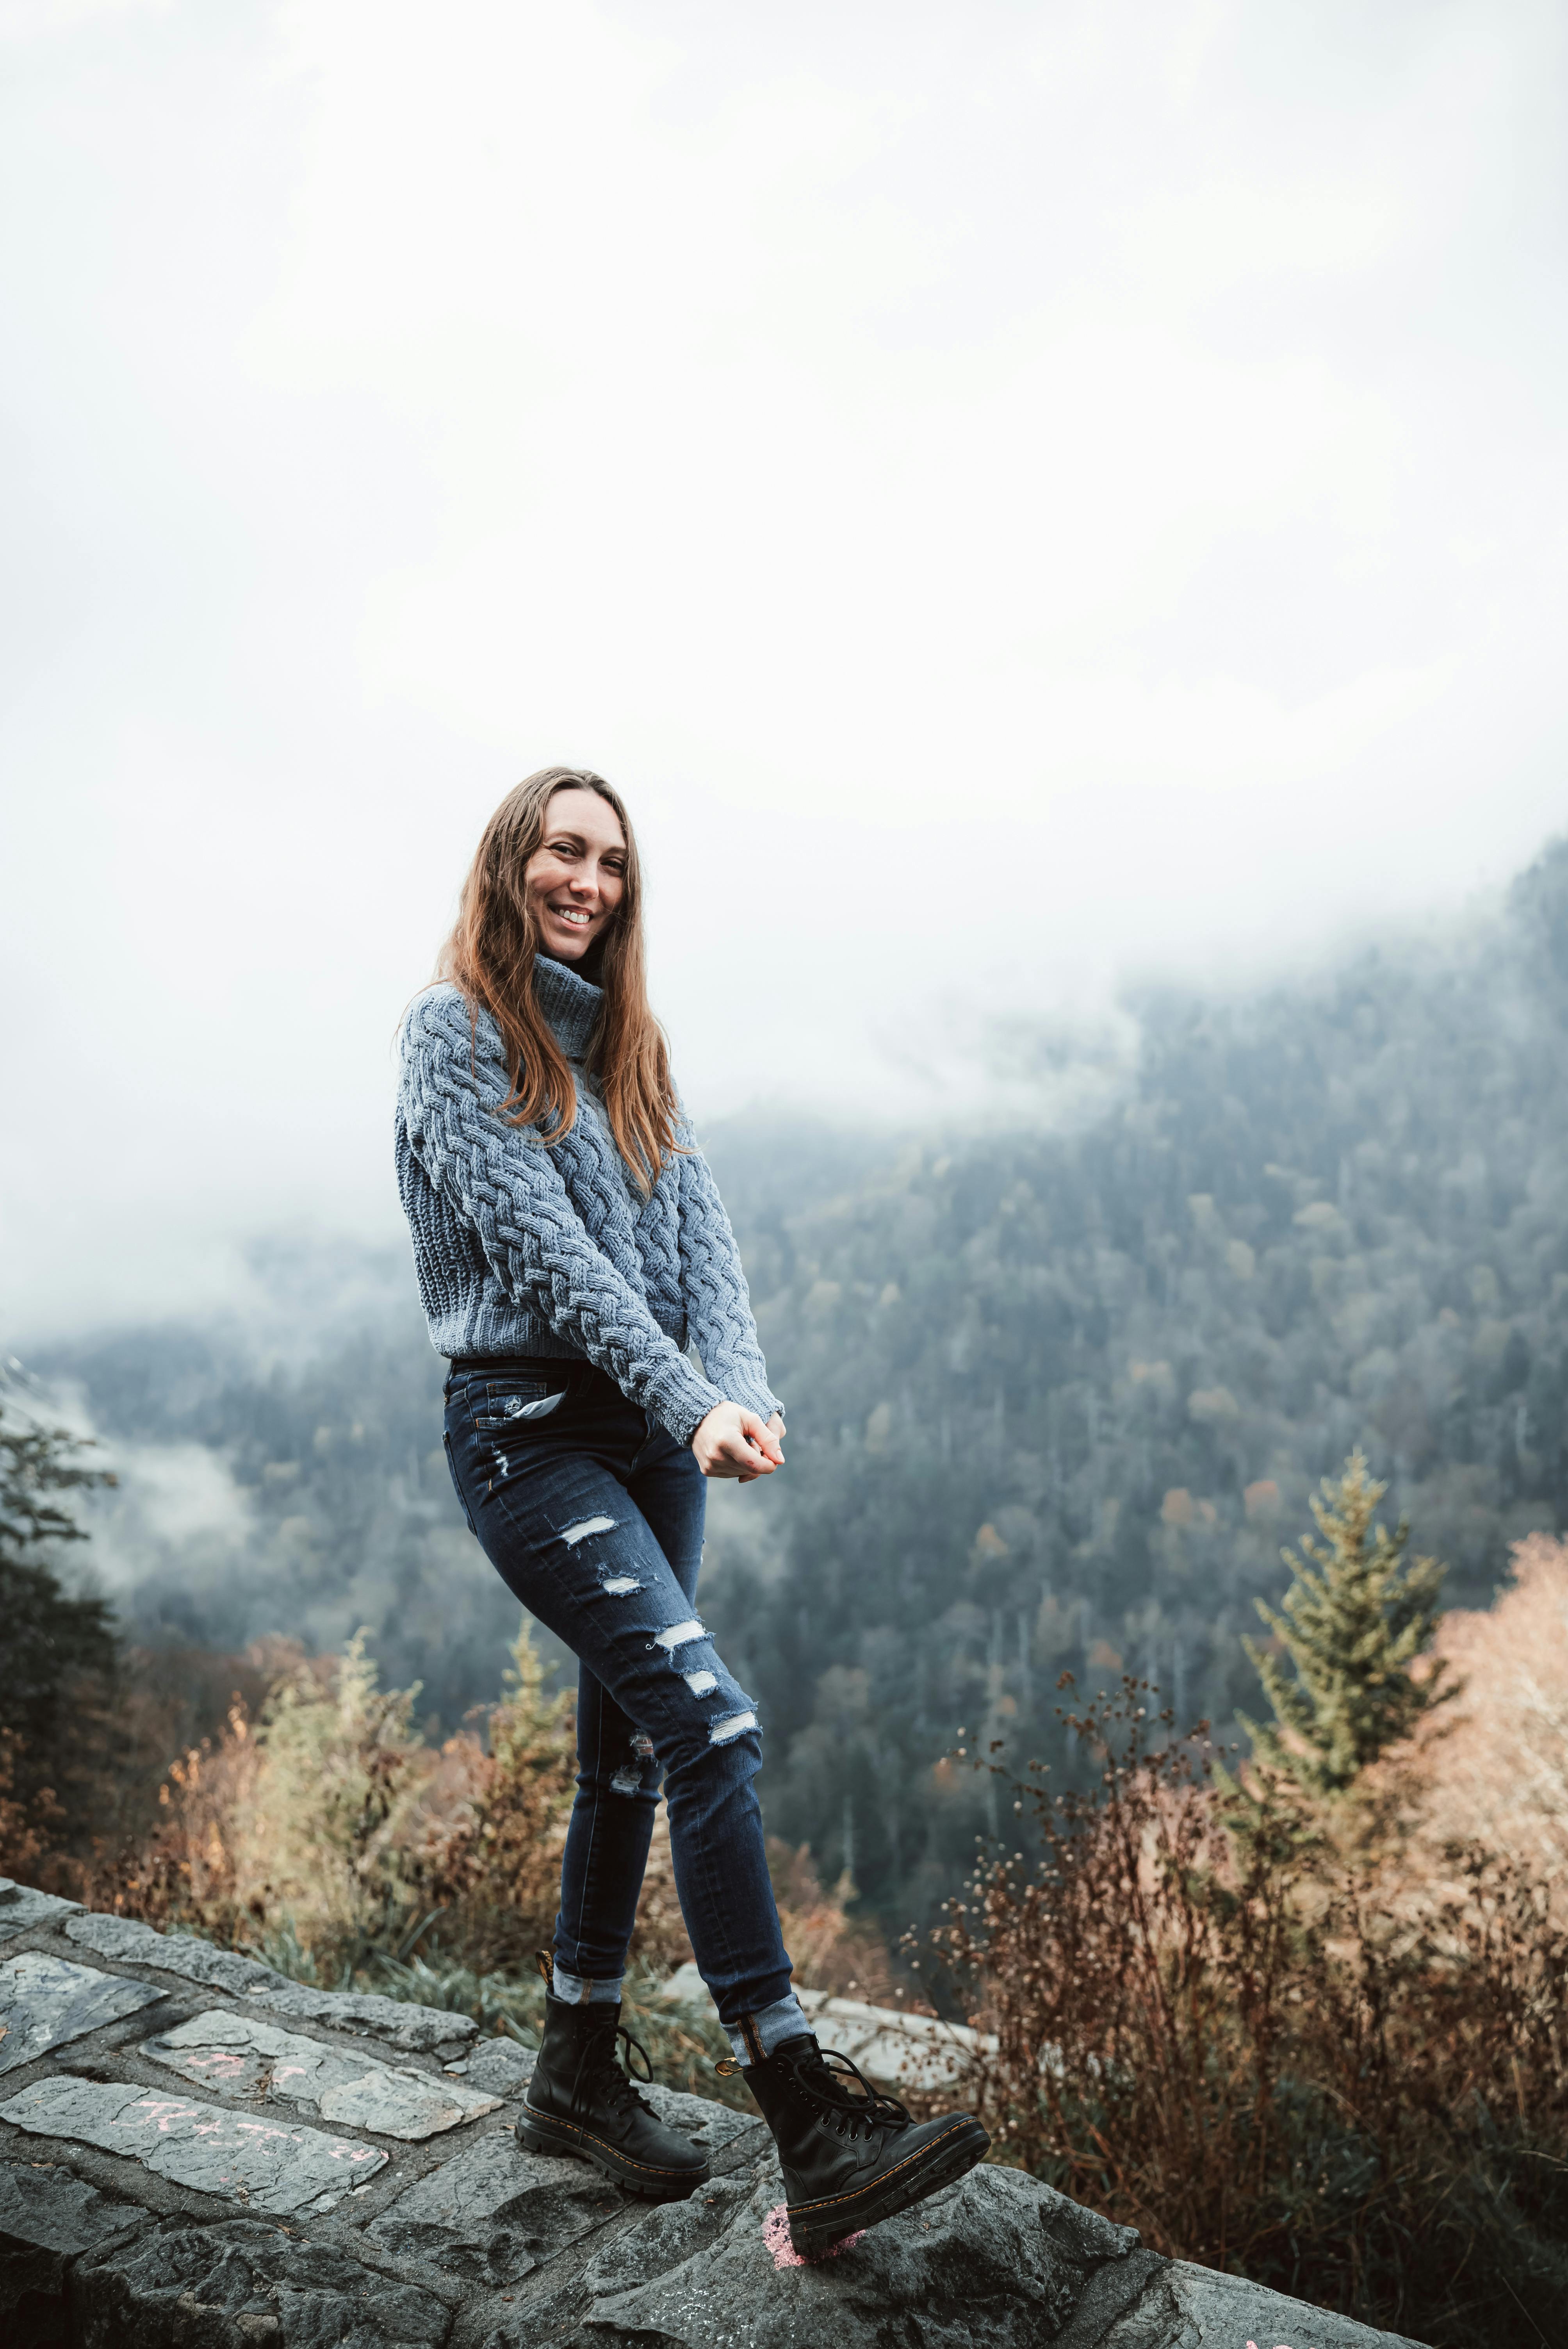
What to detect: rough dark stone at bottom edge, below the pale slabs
<box><xmin>73</xmin><ymin>2217</ymin><xmax>451</xmax><ymax>2349</ymax></box>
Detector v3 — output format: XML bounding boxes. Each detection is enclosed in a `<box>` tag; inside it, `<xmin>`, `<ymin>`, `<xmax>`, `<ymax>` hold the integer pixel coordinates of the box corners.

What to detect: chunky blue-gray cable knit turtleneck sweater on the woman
<box><xmin>397</xmin><ymin>959</ymin><xmax>782</xmax><ymax>1442</ymax></box>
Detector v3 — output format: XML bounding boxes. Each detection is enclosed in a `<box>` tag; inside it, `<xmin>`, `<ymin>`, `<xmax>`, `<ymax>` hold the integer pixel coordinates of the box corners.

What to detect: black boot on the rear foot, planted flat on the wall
<box><xmin>517</xmin><ymin>1992</ymin><xmax>709</xmax><ymax>2201</ymax></box>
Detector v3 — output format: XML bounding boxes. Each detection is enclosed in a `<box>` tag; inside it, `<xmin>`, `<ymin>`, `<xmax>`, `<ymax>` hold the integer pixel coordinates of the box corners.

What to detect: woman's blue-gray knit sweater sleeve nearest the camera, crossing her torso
<box><xmin>399</xmin><ymin>994</ymin><xmax>725</xmax><ymax>1442</ymax></box>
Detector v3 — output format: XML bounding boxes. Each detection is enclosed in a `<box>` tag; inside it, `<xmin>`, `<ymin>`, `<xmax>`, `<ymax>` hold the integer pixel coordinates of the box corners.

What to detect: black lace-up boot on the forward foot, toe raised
<box><xmin>742</xmin><ymin>2034</ymin><xmax>991</xmax><ymax>2253</ymax></box>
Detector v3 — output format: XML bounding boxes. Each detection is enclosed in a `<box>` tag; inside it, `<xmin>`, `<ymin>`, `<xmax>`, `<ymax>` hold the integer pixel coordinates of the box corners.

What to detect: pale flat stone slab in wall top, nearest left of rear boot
<box><xmin>141</xmin><ymin>2006</ymin><xmax>500</xmax><ymax>2142</ymax></box>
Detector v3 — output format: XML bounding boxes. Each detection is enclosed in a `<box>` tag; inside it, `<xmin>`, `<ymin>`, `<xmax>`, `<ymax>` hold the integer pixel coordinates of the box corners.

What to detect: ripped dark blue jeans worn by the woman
<box><xmin>446</xmin><ymin>1360</ymin><xmax>807</xmax><ymax>2044</ymax></box>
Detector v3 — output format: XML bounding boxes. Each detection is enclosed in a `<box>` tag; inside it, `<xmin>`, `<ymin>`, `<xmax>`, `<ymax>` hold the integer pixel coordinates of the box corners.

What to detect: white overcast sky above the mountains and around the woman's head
<box><xmin>0</xmin><ymin>0</ymin><xmax>1568</xmax><ymax>1341</ymax></box>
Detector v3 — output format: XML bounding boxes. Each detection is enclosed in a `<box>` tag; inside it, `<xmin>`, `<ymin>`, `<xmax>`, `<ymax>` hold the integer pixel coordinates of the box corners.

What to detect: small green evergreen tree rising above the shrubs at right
<box><xmin>1239</xmin><ymin>1452</ymin><xmax>1458</xmax><ymax>1797</ymax></box>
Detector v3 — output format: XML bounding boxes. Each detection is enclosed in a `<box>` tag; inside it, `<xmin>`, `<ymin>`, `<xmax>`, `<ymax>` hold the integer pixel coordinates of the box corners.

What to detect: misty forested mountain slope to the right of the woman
<box><xmin>709</xmin><ymin>848</ymin><xmax>1568</xmax><ymax>1914</ymax></box>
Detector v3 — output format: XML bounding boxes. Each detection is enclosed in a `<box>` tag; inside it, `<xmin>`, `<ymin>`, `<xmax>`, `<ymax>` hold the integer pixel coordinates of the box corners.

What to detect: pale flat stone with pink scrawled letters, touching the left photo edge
<box><xmin>0</xmin><ymin>2076</ymin><xmax>387</xmax><ymax>2217</ymax></box>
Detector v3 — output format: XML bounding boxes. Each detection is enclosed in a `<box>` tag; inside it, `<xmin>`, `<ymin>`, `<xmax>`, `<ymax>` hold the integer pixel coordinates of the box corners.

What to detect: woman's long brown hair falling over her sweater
<box><xmin>437</xmin><ymin>766</ymin><xmax>678</xmax><ymax>1189</ymax></box>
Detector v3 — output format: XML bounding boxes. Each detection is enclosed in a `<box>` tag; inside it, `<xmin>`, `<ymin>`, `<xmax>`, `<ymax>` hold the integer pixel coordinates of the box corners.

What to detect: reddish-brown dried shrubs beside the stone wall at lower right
<box><xmin>911</xmin><ymin>1679</ymin><xmax>1568</xmax><ymax>2349</ymax></box>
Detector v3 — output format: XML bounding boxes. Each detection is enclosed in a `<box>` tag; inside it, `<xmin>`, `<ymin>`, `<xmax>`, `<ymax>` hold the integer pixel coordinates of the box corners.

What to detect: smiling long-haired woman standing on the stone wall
<box><xmin>397</xmin><ymin>766</ymin><xmax>988</xmax><ymax>2250</ymax></box>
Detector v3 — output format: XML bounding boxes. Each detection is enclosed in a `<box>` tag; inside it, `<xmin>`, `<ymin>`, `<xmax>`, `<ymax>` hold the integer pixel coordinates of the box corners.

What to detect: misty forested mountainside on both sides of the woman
<box><xmin>35</xmin><ymin>846</ymin><xmax>1568</xmax><ymax>1924</ymax></box>
